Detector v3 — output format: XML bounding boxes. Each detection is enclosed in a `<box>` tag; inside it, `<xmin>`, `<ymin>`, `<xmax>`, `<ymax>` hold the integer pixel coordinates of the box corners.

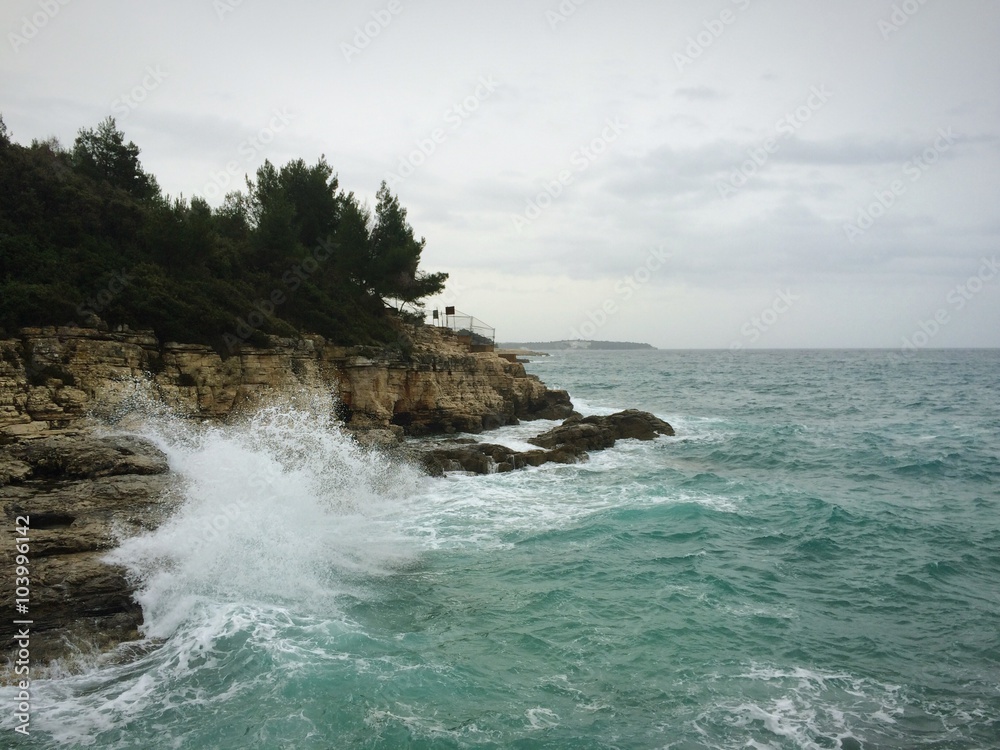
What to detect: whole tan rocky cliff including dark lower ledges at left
<box><xmin>0</xmin><ymin>325</ymin><xmax>572</xmax><ymax>661</ymax></box>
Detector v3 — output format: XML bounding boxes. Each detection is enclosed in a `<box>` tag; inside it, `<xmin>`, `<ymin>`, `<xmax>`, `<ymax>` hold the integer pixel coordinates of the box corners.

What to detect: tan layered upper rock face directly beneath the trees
<box><xmin>0</xmin><ymin>328</ymin><xmax>572</xmax><ymax>440</ymax></box>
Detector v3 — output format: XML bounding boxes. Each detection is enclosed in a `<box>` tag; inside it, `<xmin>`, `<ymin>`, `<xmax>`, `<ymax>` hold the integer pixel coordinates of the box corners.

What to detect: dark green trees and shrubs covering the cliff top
<box><xmin>0</xmin><ymin>118</ymin><xmax>447</xmax><ymax>352</ymax></box>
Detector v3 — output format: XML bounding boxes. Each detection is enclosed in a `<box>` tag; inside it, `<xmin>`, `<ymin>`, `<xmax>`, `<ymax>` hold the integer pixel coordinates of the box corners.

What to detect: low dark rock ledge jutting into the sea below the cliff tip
<box><xmin>414</xmin><ymin>409</ymin><xmax>674</xmax><ymax>476</ymax></box>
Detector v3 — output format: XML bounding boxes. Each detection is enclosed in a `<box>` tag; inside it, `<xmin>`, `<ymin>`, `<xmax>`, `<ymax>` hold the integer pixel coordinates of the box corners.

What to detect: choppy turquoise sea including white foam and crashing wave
<box><xmin>0</xmin><ymin>349</ymin><xmax>1000</xmax><ymax>750</ymax></box>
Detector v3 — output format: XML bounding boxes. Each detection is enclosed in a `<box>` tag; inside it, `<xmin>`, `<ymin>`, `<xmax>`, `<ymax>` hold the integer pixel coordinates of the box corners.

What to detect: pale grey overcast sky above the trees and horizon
<box><xmin>0</xmin><ymin>0</ymin><xmax>1000</xmax><ymax>351</ymax></box>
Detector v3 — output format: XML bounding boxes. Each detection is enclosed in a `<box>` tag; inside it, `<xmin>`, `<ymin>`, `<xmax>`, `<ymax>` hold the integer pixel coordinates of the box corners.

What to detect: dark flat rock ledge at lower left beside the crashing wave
<box><xmin>0</xmin><ymin>430</ymin><xmax>174</xmax><ymax>664</ymax></box>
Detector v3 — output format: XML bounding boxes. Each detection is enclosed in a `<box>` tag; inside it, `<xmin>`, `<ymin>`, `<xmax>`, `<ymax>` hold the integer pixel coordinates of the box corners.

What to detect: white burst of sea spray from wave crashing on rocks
<box><xmin>108</xmin><ymin>393</ymin><xmax>421</xmax><ymax>638</ymax></box>
